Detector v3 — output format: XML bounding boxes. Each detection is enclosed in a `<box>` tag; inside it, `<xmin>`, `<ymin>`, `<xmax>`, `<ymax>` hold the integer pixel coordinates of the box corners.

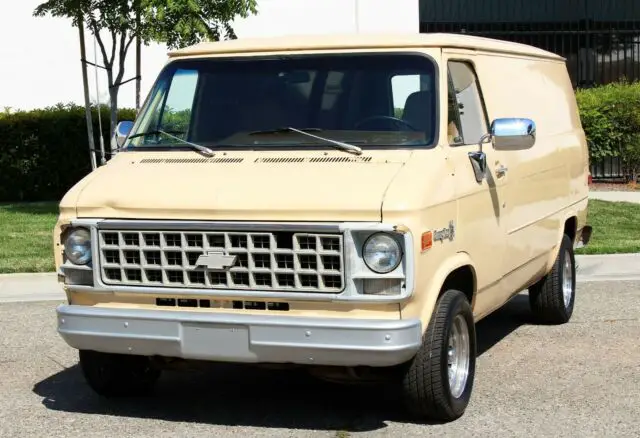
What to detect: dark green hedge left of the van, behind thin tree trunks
<box><xmin>0</xmin><ymin>104</ymin><xmax>135</xmax><ymax>202</ymax></box>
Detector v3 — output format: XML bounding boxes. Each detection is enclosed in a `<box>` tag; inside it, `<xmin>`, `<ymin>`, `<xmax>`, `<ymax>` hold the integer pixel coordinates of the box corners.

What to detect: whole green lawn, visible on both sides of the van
<box><xmin>0</xmin><ymin>200</ymin><xmax>640</xmax><ymax>273</ymax></box>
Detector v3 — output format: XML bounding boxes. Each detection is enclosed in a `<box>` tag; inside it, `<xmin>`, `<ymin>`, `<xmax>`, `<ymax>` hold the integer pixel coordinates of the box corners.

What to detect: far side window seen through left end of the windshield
<box><xmin>158</xmin><ymin>70</ymin><xmax>198</xmax><ymax>138</ymax></box>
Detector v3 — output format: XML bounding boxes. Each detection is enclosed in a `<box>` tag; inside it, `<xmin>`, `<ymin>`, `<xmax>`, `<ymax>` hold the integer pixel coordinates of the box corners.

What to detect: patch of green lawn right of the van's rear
<box><xmin>577</xmin><ymin>199</ymin><xmax>640</xmax><ymax>254</ymax></box>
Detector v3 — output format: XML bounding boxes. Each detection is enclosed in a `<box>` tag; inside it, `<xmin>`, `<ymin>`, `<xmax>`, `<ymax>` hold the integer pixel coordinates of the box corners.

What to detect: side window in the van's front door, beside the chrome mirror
<box><xmin>447</xmin><ymin>61</ymin><xmax>489</xmax><ymax>145</ymax></box>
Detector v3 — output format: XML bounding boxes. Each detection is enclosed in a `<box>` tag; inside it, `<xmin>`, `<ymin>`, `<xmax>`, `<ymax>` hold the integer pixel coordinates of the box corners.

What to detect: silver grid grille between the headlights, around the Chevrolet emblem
<box><xmin>98</xmin><ymin>230</ymin><xmax>345</xmax><ymax>293</ymax></box>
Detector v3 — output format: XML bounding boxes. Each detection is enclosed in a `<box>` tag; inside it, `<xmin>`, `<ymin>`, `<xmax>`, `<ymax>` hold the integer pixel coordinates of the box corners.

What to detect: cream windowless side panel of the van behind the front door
<box><xmin>476</xmin><ymin>53</ymin><xmax>588</xmax><ymax>293</ymax></box>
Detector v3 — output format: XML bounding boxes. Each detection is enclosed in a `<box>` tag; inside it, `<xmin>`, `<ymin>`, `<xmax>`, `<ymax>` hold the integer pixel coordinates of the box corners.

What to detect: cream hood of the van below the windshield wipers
<box><xmin>67</xmin><ymin>150</ymin><xmax>411</xmax><ymax>221</ymax></box>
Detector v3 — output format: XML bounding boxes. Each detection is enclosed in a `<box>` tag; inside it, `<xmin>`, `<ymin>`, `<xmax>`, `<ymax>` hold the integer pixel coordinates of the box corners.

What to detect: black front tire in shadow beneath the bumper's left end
<box><xmin>79</xmin><ymin>350</ymin><xmax>161</xmax><ymax>397</ymax></box>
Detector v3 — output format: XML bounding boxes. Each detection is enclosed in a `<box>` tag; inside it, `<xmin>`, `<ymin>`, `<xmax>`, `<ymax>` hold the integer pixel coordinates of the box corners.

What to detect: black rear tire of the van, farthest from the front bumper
<box><xmin>529</xmin><ymin>234</ymin><xmax>576</xmax><ymax>324</ymax></box>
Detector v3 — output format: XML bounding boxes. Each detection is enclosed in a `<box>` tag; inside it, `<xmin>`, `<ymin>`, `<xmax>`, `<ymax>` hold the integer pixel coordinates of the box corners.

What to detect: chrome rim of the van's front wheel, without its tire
<box><xmin>447</xmin><ymin>315</ymin><xmax>470</xmax><ymax>398</ymax></box>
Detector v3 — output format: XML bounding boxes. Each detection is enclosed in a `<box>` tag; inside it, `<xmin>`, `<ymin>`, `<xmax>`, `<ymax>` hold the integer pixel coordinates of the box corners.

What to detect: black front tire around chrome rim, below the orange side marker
<box><xmin>402</xmin><ymin>290</ymin><xmax>476</xmax><ymax>422</ymax></box>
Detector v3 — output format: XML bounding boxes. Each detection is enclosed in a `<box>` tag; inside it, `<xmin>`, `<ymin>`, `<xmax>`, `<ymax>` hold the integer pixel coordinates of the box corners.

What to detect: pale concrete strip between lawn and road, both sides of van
<box><xmin>0</xmin><ymin>253</ymin><xmax>640</xmax><ymax>303</ymax></box>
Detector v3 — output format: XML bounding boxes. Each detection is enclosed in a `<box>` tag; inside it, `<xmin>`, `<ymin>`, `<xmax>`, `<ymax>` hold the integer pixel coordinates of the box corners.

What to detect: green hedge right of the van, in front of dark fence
<box><xmin>576</xmin><ymin>81</ymin><xmax>640</xmax><ymax>179</ymax></box>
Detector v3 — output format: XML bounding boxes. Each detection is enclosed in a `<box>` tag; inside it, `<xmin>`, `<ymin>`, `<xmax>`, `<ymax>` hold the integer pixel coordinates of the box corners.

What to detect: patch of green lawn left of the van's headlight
<box><xmin>0</xmin><ymin>202</ymin><xmax>58</xmax><ymax>274</ymax></box>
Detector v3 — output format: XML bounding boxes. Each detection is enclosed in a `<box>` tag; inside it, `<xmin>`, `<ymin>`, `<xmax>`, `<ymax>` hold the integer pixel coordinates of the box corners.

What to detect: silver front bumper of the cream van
<box><xmin>56</xmin><ymin>305</ymin><xmax>422</xmax><ymax>366</ymax></box>
